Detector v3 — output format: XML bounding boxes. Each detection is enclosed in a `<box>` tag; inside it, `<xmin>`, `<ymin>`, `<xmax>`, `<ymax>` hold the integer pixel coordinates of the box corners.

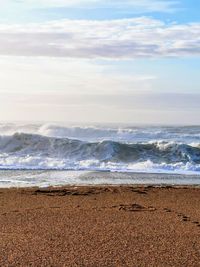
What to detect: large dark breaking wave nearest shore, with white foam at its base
<box><xmin>0</xmin><ymin>133</ymin><xmax>200</xmax><ymax>174</ymax></box>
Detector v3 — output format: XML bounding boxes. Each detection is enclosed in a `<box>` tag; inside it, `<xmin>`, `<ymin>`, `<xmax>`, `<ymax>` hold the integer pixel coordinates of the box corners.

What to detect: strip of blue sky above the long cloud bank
<box><xmin>0</xmin><ymin>0</ymin><xmax>200</xmax><ymax>23</ymax></box>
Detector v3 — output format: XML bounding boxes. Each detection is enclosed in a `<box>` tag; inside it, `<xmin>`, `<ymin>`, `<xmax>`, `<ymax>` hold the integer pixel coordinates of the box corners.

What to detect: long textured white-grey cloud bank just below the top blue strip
<box><xmin>0</xmin><ymin>17</ymin><xmax>200</xmax><ymax>59</ymax></box>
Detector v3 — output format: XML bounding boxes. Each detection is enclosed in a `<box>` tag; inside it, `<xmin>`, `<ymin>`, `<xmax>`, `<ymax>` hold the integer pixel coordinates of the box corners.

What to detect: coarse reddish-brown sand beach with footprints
<box><xmin>0</xmin><ymin>186</ymin><xmax>200</xmax><ymax>267</ymax></box>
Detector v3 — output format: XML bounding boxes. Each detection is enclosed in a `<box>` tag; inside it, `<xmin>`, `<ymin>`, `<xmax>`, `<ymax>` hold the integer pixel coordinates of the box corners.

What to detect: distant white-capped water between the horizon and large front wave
<box><xmin>0</xmin><ymin>123</ymin><xmax>200</xmax><ymax>144</ymax></box>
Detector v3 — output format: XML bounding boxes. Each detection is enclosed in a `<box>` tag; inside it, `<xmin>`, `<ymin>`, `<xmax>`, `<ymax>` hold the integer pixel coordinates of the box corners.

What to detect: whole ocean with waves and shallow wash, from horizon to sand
<box><xmin>0</xmin><ymin>123</ymin><xmax>200</xmax><ymax>187</ymax></box>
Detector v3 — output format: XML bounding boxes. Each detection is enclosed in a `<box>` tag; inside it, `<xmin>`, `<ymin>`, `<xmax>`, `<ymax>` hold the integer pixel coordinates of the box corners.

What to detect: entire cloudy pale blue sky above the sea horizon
<box><xmin>0</xmin><ymin>0</ymin><xmax>200</xmax><ymax>125</ymax></box>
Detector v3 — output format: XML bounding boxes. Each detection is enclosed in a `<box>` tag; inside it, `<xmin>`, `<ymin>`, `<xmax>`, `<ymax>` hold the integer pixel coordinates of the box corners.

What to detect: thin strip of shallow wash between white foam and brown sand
<box><xmin>0</xmin><ymin>170</ymin><xmax>200</xmax><ymax>188</ymax></box>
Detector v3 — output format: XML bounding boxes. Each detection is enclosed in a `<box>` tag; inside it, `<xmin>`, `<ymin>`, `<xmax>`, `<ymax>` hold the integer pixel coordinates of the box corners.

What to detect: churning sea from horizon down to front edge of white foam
<box><xmin>0</xmin><ymin>124</ymin><xmax>200</xmax><ymax>174</ymax></box>
